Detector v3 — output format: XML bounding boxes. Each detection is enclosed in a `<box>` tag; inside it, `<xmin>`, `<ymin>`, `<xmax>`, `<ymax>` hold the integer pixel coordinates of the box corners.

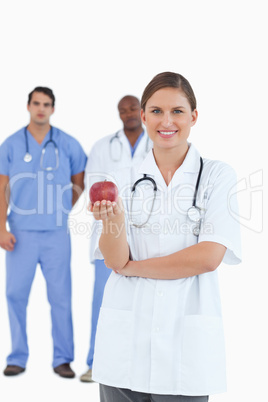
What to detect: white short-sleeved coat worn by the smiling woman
<box><xmin>93</xmin><ymin>145</ymin><xmax>241</xmax><ymax>396</ymax></box>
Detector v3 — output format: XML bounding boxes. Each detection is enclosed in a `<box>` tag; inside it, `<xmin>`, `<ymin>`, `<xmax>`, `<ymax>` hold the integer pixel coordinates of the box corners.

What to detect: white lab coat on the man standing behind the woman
<box><xmin>85</xmin><ymin>130</ymin><xmax>152</xmax><ymax>263</ymax></box>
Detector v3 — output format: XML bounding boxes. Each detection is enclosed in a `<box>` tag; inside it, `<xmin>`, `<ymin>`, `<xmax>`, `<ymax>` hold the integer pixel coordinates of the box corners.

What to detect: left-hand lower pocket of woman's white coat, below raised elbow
<box><xmin>93</xmin><ymin>307</ymin><xmax>133</xmax><ymax>386</ymax></box>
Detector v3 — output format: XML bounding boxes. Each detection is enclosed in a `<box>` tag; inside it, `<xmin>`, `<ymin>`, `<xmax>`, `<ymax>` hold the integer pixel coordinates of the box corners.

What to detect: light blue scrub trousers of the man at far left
<box><xmin>6</xmin><ymin>230</ymin><xmax>74</xmax><ymax>367</ymax></box>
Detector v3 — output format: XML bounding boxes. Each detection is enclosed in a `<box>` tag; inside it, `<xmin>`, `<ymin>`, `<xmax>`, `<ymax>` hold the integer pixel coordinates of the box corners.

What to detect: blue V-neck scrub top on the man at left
<box><xmin>0</xmin><ymin>127</ymin><xmax>87</xmax><ymax>231</ymax></box>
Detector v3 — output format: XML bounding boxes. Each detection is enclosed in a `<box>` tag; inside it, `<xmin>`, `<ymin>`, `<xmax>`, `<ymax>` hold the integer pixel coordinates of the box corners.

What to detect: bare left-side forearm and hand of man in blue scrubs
<box><xmin>0</xmin><ymin>174</ymin><xmax>16</xmax><ymax>251</ymax></box>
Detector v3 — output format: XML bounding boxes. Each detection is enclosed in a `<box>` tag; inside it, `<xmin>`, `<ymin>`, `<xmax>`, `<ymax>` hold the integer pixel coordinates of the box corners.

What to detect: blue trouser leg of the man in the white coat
<box><xmin>87</xmin><ymin>260</ymin><xmax>112</xmax><ymax>368</ymax></box>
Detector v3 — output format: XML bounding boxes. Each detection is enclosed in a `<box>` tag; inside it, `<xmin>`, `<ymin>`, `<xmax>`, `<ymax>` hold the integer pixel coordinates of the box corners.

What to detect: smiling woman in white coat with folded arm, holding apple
<box><xmin>91</xmin><ymin>72</ymin><xmax>240</xmax><ymax>402</ymax></box>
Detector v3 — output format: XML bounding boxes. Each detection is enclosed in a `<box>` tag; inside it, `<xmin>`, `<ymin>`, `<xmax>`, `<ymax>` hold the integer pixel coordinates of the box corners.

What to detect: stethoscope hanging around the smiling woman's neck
<box><xmin>130</xmin><ymin>157</ymin><xmax>203</xmax><ymax>236</ymax></box>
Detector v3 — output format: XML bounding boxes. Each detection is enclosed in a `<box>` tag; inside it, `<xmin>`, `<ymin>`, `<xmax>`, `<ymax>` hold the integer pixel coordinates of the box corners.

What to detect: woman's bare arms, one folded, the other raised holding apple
<box><xmin>91</xmin><ymin>200</ymin><xmax>226</xmax><ymax>279</ymax></box>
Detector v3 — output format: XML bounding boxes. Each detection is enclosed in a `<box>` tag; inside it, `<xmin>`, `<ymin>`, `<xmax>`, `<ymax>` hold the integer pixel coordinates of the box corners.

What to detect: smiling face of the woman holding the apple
<box><xmin>141</xmin><ymin>88</ymin><xmax>198</xmax><ymax>149</ymax></box>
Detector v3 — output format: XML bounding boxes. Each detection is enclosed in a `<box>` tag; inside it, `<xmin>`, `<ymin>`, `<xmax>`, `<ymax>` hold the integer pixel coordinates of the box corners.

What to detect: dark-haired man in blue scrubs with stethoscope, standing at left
<box><xmin>0</xmin><ymin>87</ymin><xmax>87</xmax><ymax>378</ymax></box>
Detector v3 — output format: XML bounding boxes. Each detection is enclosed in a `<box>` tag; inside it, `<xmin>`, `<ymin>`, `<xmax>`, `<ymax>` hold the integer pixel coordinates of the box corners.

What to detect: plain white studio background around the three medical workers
<box><xmin>0</xmin><ymin>0</ymin><xmax>268</xmax><ymax>402</ymax></box>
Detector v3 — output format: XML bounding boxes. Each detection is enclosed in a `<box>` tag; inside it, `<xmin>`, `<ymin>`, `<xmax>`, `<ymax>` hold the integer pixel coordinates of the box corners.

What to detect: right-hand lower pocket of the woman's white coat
<box><xmin>181</xmin><ymin>315</ymin><xmax>226</xmax><ymax>395</ymax></box>
